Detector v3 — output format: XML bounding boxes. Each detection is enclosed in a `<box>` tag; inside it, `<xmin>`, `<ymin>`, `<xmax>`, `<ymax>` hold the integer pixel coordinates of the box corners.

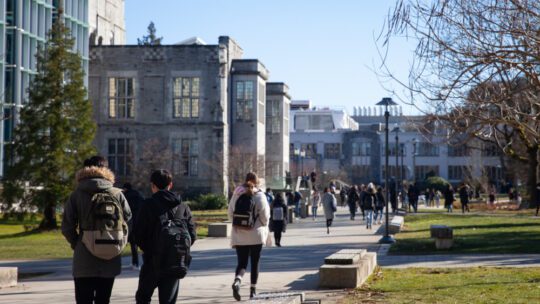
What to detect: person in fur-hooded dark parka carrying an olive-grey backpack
<box><xmin>62</xmin><ymin>156</ymin><xmax>131</xmax><ymax>303</ymax></box>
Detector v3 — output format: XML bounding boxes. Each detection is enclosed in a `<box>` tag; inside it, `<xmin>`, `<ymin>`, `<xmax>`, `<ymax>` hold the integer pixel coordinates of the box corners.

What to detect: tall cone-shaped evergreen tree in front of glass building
<box><xmin>2</xmin><ymin>17</ymin><xmax>96</xmax><ymax>229</ymax></box>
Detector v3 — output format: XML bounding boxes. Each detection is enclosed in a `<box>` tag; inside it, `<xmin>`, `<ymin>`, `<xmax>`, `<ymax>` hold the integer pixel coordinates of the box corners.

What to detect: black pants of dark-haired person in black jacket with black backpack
<box><xmin>135</xmin><ymin>255</ymin><xmax>180</xmax><ymax>304</ymax></box>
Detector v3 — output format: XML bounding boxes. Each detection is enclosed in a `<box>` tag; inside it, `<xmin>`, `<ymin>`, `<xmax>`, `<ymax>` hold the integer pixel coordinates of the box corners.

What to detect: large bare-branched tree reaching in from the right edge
<box><xmin>380</xmin><ymin>0</ymin><xmax>540</xmax><ymax>204</ymax></box>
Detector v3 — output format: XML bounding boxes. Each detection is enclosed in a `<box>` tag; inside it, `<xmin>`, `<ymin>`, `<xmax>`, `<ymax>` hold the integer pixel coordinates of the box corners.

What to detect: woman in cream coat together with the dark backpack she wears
<box><xmin>228</xmin><ymin>172</ymin><xmax>270</xmax><ymax>301</ymax></box>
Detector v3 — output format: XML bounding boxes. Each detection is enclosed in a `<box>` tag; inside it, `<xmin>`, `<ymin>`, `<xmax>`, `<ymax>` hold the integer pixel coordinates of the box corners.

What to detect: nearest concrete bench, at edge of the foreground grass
<box><xmin>319</xmin><ymin>249</ymin><xmax>377</xmax><ymax>288</ymax></box>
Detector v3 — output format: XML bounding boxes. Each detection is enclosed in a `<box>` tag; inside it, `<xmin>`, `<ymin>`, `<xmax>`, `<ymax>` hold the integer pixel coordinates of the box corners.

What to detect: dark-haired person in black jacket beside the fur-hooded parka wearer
<box><xmin>133</xmin><ymin>169</ymin><xmax>197</xmax><ymax>304</ymax></box>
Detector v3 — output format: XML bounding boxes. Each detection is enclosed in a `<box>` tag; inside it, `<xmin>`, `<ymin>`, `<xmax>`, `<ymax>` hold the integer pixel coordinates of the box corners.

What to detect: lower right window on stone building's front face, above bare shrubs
<box><xmin>173</xmin><ymin>138</ymin><xmax>199</xmax><ymax>176</ymax></box>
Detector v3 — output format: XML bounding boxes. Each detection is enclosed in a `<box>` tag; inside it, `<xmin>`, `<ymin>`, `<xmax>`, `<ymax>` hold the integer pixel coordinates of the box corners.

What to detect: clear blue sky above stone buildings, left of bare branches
<box><xmin>125</xmin><ymin>0</ymin><xmax>412</xmax><ymax>113</ymax></box>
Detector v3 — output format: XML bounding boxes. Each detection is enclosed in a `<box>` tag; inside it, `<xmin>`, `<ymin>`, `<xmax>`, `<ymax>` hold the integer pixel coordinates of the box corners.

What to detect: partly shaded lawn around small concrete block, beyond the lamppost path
<box><xmin>390</xmin><ymin>211</ymin><xmax>540</xmax><ymax>254</ymax></box>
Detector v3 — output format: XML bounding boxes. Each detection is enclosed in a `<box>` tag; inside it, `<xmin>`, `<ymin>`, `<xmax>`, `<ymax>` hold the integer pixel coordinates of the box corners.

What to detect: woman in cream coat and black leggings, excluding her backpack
<box><xmin>228</xmin><ymin>173</ymin><xmax>270</xmax><ymax>301</ymax></box>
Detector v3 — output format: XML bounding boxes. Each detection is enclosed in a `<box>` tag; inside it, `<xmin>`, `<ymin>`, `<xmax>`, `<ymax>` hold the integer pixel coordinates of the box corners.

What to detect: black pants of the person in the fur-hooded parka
<box><xmin>73</xmin><ymin>277</ymin><xmax>114</xmax><ymax>304</ymax></box>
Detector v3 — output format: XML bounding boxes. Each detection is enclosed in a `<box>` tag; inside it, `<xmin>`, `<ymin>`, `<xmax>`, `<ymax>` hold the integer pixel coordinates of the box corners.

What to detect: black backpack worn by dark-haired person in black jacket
<box><xmin>153</xmin><ymin>207</ymin><xmax>191</xmax><ymax>279</ymax></box>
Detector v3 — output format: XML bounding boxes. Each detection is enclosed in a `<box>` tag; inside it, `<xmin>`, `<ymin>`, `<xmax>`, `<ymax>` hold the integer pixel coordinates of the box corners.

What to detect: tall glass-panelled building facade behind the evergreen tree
<box><xmin>0</xmin><ymin>0</ymin><xmax>89</xmax><ymax>175</ymax></box>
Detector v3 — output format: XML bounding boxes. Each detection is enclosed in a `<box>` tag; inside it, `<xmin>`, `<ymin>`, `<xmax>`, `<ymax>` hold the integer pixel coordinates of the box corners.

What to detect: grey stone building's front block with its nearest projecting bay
<box><xmin>89</xmin><ymin>37</ymin><xmax>288</xmax><ymax>196</ymax></box>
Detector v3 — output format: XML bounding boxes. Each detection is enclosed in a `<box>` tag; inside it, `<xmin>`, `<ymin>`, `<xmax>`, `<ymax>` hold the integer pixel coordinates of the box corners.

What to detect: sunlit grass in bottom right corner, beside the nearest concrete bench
<box><xmin>341</xmin><ymin>267</ymin><xmax>540</xmax><ymax>304</ymax></box>
